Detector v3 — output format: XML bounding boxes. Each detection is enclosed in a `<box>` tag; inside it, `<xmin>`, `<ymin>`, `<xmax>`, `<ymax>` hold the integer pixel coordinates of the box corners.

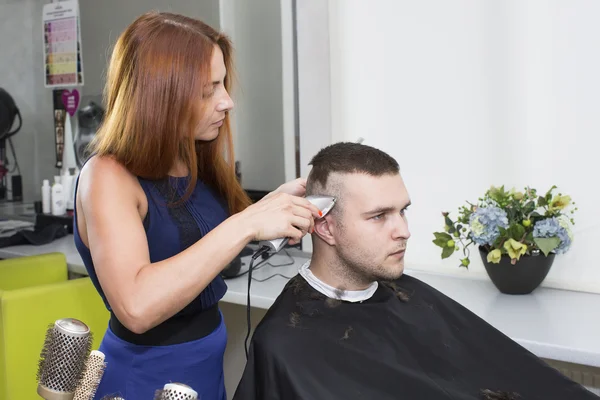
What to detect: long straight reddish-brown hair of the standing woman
<box><xmin>91</xmin><ymin>12</ymin><xmax>251</xmax><ymax>214</ymax></box>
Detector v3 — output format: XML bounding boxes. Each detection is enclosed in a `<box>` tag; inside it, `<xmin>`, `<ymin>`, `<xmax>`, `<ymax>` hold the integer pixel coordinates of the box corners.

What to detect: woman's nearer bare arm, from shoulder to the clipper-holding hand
<box><xmin>77</xmin><ymin>157</ymin><xmax>318</xmax><ymax>334</ymax></box>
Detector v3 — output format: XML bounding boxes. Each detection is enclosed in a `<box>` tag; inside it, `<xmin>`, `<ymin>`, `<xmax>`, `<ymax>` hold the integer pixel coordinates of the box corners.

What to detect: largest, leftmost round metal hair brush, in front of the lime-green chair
<box><xmin>37</xmin><ymin>318</ymin><xmax>93</xmax><ymax>400</ymax></box>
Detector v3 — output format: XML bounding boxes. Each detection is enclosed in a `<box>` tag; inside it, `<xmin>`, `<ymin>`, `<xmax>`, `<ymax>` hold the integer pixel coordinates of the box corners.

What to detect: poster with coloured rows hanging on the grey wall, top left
<box><xmin>42</xmin><ymin>0</ymin><xmax>83</xmax><ymax>88</ymax></box>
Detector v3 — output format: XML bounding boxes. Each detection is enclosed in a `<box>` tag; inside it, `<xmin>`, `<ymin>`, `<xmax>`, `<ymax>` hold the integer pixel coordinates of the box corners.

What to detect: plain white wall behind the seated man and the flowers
<box><xmin>314</xmin><ymin>0</ymin><xmax>600</xmax><ymax>292</ymax></box>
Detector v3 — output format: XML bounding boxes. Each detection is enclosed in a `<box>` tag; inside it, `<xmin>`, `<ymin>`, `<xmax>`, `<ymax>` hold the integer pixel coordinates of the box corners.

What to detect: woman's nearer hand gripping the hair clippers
<box><xmin>240</xmin><ymin>193</ymin><xmax>321</xmax><ymax>245</ymax></box>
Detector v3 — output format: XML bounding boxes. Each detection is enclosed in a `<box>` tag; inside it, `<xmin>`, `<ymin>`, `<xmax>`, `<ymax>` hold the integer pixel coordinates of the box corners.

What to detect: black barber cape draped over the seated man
<box><xmin>234</xmin><ymin>275</ymin><xmax>598</xmax><ymax>400</ymax></box>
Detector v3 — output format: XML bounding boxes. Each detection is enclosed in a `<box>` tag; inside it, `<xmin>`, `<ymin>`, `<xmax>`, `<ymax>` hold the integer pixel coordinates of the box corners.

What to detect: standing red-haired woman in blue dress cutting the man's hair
<box><xmin>74</xmin><ymin>13</ymin><xmax>319</xmax><ymax>400</ymax></box>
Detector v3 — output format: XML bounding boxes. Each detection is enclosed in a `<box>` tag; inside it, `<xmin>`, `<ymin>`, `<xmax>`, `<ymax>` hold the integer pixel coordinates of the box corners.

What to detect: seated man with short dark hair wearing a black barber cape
<box><xmin>234</xmin><ymin>143</ymin><xmax>597</xmax><ymax>400</ymax></box>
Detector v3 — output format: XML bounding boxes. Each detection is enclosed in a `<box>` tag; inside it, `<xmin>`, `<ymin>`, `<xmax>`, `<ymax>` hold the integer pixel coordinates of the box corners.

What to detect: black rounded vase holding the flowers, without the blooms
<box><xmin>479</xmin><ymin>247</ymin><xmax>555</xmax><ymax>294</ymax></box>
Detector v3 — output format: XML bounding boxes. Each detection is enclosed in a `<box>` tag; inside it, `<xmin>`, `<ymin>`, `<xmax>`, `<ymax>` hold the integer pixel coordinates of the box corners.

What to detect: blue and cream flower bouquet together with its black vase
<box><xmin>433</xmin><ymin>186</ymin><xmax>577</xmax><ymax>294</ymax></box>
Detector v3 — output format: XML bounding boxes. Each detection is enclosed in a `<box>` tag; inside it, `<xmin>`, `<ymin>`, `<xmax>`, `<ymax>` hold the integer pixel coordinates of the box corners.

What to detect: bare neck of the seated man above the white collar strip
<box><xmin>310</xmin><ymin>252</ymin><xmax>373</xmax><ymax>291</ymax></box>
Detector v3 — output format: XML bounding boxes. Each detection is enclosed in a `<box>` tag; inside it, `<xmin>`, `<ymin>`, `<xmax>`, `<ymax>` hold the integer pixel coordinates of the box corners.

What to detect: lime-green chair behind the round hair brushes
<box><xmin>0</xmin><ymin>253</ymin><xmax>109</xmax><ymax>400</ymax></box>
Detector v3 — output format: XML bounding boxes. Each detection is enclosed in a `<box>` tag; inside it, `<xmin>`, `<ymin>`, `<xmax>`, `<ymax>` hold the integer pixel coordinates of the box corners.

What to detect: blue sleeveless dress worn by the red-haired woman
<box><xmin>73</xmin><ymin>173</ymin><xmax>229</xmax><ymax>400</ymax></box>
